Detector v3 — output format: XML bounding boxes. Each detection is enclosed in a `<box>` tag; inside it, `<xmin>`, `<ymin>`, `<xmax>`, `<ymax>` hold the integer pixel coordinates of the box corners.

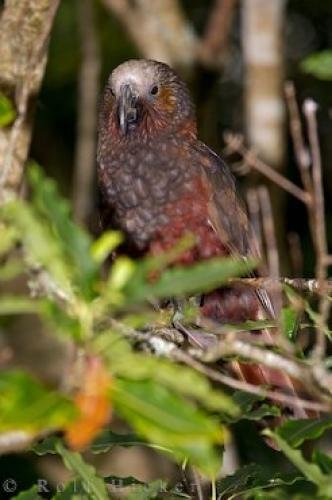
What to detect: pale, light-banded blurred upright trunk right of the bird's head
<box><xmin>242</xmin><ymin>0</ymin><xmax>285</xmax><ymax>168</ymax></box>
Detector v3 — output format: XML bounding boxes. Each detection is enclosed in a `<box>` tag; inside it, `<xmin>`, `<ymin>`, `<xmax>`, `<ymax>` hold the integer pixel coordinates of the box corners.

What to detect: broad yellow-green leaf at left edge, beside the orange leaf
<box><xmin>0</xmin><ymin>370</ymin><xmax>77</xmax><ymax>434</ymax></box>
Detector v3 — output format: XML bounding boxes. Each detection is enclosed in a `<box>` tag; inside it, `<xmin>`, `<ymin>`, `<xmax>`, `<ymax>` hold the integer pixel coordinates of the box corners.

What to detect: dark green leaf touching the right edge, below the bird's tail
<box><xmin>276</xmin><ymin>416</ymin><xmax>332</xmax><ymax>448</ymax></box>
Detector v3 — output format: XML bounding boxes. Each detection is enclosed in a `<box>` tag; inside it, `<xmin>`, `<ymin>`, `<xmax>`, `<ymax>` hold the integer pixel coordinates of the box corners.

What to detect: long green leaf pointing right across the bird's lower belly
<box><xmin>124</xmin><ymin>258</ymin><xmax>254</xmax><ymax>302</ymax></box>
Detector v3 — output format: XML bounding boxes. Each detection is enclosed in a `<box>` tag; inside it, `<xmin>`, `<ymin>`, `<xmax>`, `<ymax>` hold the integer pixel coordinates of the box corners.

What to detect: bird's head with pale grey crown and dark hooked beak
<box><xmin>100</xmin><ymin>59</ymin><xmax>196</xmax><ymax>141</ymax></box>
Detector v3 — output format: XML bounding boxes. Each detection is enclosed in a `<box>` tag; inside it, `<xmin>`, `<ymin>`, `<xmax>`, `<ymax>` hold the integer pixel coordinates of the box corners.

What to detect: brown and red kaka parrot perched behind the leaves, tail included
<box><xmin>97</xmin><ymin>60</ymin><xmax>307</xmax><ymax>418</ymax></box>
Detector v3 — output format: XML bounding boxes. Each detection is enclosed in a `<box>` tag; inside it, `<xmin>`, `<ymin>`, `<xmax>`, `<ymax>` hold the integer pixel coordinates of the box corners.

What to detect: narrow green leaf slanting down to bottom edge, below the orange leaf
<box><xmin>56</xmin><ymin>441</ymin><xmax>109</xmax><ymax>500</ymax></box>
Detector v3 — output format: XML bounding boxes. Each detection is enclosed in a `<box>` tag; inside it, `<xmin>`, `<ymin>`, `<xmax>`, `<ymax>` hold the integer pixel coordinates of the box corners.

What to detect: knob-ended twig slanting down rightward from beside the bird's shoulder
<box><xmin>224</xmin><ymin>132</ymin><xmax>311</xmax><ymax>205</ymax></box>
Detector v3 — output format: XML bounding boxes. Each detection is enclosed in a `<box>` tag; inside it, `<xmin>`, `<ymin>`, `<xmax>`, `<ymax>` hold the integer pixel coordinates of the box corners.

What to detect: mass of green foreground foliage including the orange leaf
<box><xmin>0</xmin><ymin>165</ymin><xmax>332</xmax><ymax>500</ymax></box>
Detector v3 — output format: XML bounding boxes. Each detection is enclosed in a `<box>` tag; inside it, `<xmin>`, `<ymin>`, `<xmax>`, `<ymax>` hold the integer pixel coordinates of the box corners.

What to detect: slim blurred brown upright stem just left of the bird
<box><xmin>73</xmin><ymin>0</ymin><xmax>100</xmax><ymax>222</ymax></box>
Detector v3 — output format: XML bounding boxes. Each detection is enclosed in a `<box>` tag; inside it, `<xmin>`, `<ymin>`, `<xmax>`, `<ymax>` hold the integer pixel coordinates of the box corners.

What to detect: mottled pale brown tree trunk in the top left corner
<box><xmin>0</xmin><ymin>0</ymin><xmax>60</xmax><ymax>198</ymax></box>
